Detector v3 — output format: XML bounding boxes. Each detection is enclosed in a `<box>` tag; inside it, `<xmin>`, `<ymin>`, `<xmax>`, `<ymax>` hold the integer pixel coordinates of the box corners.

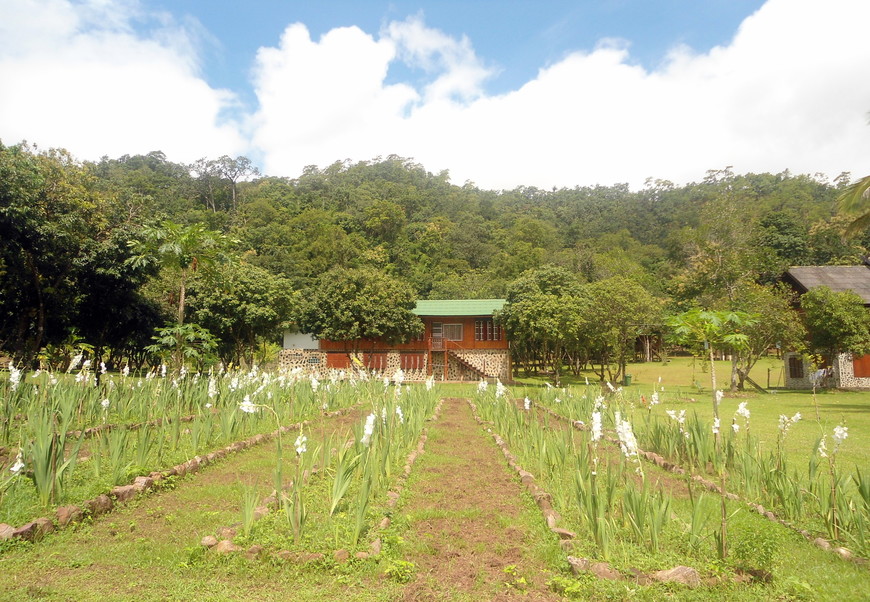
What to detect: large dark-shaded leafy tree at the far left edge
<box><xmin>0</xmin><ymin>144</ymin><xmax>110</xmax><ymax>365</ymax></box>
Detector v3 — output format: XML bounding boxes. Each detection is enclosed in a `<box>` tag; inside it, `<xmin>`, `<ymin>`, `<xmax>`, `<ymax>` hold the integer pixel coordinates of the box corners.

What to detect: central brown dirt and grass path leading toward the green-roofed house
<box><xmin>400</xmin><ymin>398</ymin><xmax>559</xmax><ymax>600</ymax></box>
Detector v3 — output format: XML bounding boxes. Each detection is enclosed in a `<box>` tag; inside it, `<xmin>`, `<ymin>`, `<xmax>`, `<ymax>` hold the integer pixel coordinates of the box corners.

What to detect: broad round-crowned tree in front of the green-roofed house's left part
<box><xmin>296</xmin><ymin>268</ymin><xmax>423</xmax><ymax>356</ymax></box>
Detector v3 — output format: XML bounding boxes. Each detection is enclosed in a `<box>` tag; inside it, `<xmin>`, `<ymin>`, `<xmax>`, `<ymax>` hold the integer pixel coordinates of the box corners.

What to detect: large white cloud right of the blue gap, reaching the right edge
<box><xmin>250</xmin><ymin>0</ymin><xmax>870</xmax><ymax>188</ymax></box>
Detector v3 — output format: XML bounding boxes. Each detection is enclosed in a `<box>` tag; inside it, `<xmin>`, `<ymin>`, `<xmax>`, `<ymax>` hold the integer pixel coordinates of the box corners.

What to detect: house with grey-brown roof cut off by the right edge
<box><xmin>783</xmin><ymin>263</ymin><xmax>870</xmax><ymax>389</ymax></box>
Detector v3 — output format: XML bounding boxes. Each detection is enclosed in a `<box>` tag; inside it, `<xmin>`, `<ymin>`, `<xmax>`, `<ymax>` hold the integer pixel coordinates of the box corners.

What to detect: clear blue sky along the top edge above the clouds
<box><xmin>151</xmin><ymin>0</ymin><xmax>763</xmax><ymax>102</ymax></box>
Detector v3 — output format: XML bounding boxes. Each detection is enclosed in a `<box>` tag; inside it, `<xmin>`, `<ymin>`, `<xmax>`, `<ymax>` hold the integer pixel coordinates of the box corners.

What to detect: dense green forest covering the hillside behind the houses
<box><xmin>0</xmin><ymin>144</ymin><xmax>870</xmax><ymax>376</ymax></box>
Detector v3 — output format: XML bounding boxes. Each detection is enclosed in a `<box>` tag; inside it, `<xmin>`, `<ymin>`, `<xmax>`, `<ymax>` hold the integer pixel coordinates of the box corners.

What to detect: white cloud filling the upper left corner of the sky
<box><xmin>0</xmin><ymin>0</ymin><xmax>246</xmax><ymax>161</ymax></box>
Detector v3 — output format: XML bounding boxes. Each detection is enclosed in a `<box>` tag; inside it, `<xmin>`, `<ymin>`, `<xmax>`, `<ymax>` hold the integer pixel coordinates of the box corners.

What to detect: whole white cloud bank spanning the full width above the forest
<box><xmin>0</xmin><ymin>0</ymin><xmax>870</xmax><ymax>188</ymax></box>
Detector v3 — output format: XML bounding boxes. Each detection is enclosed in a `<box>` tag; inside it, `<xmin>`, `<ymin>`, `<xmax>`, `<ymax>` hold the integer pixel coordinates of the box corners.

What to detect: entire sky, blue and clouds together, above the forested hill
<box><xmin>0</xmin><ymin>0</ymin><xmax>870</xmax><ymax>190</ymax></box>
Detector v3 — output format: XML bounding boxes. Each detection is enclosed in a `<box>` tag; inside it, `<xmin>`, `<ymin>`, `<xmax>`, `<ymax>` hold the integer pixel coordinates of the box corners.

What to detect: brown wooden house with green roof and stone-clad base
<box><xmin>279</xmin><ymin>299</ymin><xmax>511</xmax><ymax>381</ymax></box>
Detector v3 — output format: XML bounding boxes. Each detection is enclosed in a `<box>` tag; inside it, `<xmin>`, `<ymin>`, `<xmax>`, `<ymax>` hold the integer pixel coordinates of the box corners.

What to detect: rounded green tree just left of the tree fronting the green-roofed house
<box><xmin>189</xmin><ymin>262</ymin><xmax>295</xmax><ymax>364</ymax></box>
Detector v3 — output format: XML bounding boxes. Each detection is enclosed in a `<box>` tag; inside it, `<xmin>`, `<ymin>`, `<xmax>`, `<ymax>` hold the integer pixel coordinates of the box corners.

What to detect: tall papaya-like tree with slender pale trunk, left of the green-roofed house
<box><xmin>129</xmin><ymin>220</ymin><xmax>231</xmax><ymax>325</ymax></box>
